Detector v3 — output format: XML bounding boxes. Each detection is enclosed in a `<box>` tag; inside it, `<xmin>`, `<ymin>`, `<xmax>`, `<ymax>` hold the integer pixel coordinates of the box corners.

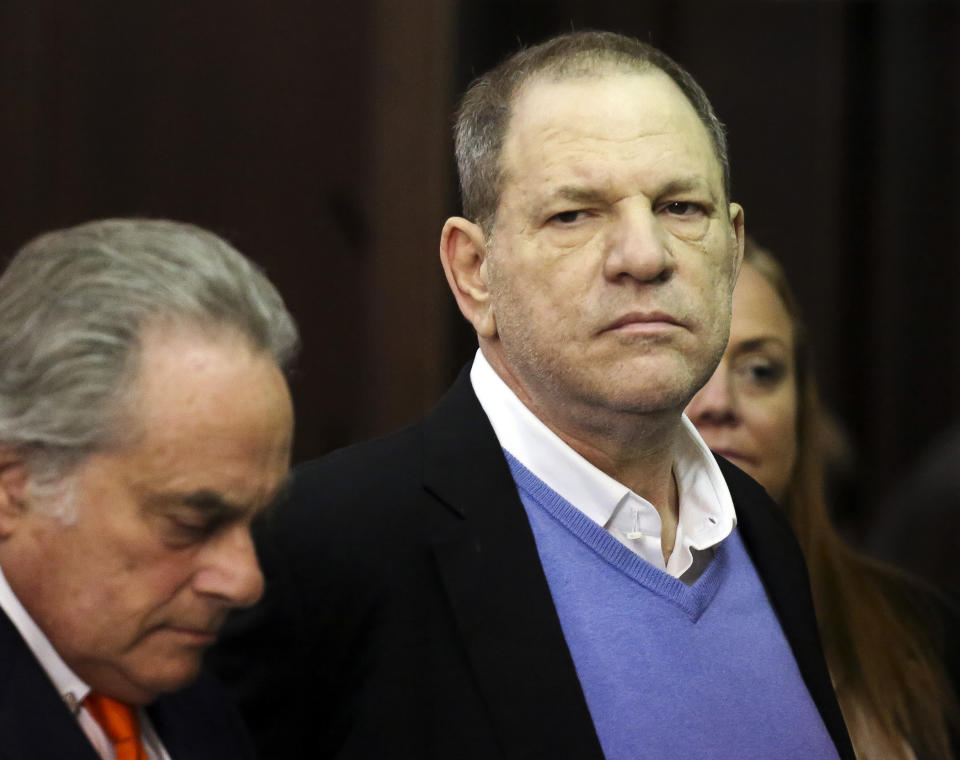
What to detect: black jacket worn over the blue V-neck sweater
<box><xmin>210</xmin><ymin>372</ymin><xmax>853</xmax><ymax>760</ymax></box>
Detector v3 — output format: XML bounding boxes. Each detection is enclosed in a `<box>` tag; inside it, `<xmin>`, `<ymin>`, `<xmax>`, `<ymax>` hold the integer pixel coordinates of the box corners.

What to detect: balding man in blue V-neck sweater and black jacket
<box><xmin>212</xmin><ymin>33</ymin><xmax>853</xmax><ymax>760</ymax></box>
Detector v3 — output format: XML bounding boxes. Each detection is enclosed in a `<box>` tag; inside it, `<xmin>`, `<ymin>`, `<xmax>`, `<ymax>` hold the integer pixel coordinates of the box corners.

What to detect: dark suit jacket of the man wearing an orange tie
<box><xmin>0</xmin><ymin>611</ymin><xmax>254</xmax><ymax>760</ymax></box>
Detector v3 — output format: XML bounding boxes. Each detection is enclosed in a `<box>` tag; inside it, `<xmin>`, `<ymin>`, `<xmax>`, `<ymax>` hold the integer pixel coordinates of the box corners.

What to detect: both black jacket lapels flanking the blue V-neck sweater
<box><xmin>416</xmin><ymin>370</ymin><xmax>854</xmax><ymax>760</ymax></box>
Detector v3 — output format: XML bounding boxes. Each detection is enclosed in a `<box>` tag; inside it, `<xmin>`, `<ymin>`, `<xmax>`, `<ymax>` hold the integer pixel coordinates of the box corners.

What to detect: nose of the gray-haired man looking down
<box><xmin>194</xmin><ymin>524</ymin><xmax>263</xmax><ymax>607</ymax></box>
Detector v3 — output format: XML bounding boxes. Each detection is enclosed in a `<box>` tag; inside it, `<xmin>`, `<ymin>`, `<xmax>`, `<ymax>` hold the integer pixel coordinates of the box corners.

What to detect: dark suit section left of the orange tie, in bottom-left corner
<box><xmin>0</xmin><ymin>612</ymin><xmax>99</xmax><ymax>760</ymax></box>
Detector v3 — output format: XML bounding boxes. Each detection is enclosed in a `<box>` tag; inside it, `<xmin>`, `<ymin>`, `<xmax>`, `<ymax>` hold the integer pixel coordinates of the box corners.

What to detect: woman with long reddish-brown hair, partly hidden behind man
<box><xmin>687</xmin><ymin>239</ymin><xmax>957</xmax><ymax>760</ymax></box>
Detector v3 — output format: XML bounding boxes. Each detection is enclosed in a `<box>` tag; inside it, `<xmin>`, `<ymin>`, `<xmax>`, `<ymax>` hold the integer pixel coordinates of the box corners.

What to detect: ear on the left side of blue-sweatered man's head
<box><xmin>440</xmin><ymin>216</ymin><xmax>497</xmax><ymax>338</ymax></box>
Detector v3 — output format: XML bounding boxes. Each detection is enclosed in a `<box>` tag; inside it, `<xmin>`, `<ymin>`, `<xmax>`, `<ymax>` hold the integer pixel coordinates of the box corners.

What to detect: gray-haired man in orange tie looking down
<box><xmin>0</xmin><ymin>220</ymin><xmax>297</xmax><ymax>760</ymax></box>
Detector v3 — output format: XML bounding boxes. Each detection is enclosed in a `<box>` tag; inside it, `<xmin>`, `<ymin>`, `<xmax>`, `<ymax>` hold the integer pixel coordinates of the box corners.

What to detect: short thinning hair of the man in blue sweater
<box><xmin>454</xmin><ymin>31</ymin><xmax>730</xmax><ymax>234</ymax></box>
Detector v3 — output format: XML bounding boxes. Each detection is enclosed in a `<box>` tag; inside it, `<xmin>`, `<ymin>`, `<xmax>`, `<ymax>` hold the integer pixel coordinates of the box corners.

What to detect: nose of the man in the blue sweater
<box><xmin>604</xmin><ymin>199</ymin><xmax>675</xmax><ymax>282</ymax></box>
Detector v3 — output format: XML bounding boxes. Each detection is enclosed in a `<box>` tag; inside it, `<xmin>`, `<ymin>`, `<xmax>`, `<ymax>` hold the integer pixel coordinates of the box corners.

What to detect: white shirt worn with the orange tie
<box><xmin>0</xmin><ymin>568</ymin><xmax>171</xmax><ymax>760</ymax></box>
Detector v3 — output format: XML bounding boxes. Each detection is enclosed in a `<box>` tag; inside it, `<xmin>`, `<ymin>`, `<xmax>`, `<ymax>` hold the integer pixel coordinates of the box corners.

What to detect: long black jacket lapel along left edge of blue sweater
<box><xmin>424</xmin><ymin>372</ymin><xmax>603</xmax><ymax>760</ymax></box>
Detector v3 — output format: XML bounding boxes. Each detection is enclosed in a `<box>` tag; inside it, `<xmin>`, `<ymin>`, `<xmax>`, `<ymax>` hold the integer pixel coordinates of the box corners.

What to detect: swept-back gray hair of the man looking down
<box><xmin>0</xmin><ymin>219</ymin><xmax>298</xmax><ymax>480</ymax></box>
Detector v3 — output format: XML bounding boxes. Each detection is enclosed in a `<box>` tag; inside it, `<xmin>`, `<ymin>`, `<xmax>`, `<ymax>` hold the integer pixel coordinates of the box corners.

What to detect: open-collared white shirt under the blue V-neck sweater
<box><xmin>470</xmin><ymin>351</ymin><xmax>737</xmax><ymax>583</ymax></box>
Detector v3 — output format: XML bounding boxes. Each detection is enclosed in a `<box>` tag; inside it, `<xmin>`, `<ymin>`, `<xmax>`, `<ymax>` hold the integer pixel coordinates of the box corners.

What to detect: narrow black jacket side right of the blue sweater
<box><xmin>717</xmin><ymin>457</ymin><xmax>854</xmax><ymax>760</ymax></box>
